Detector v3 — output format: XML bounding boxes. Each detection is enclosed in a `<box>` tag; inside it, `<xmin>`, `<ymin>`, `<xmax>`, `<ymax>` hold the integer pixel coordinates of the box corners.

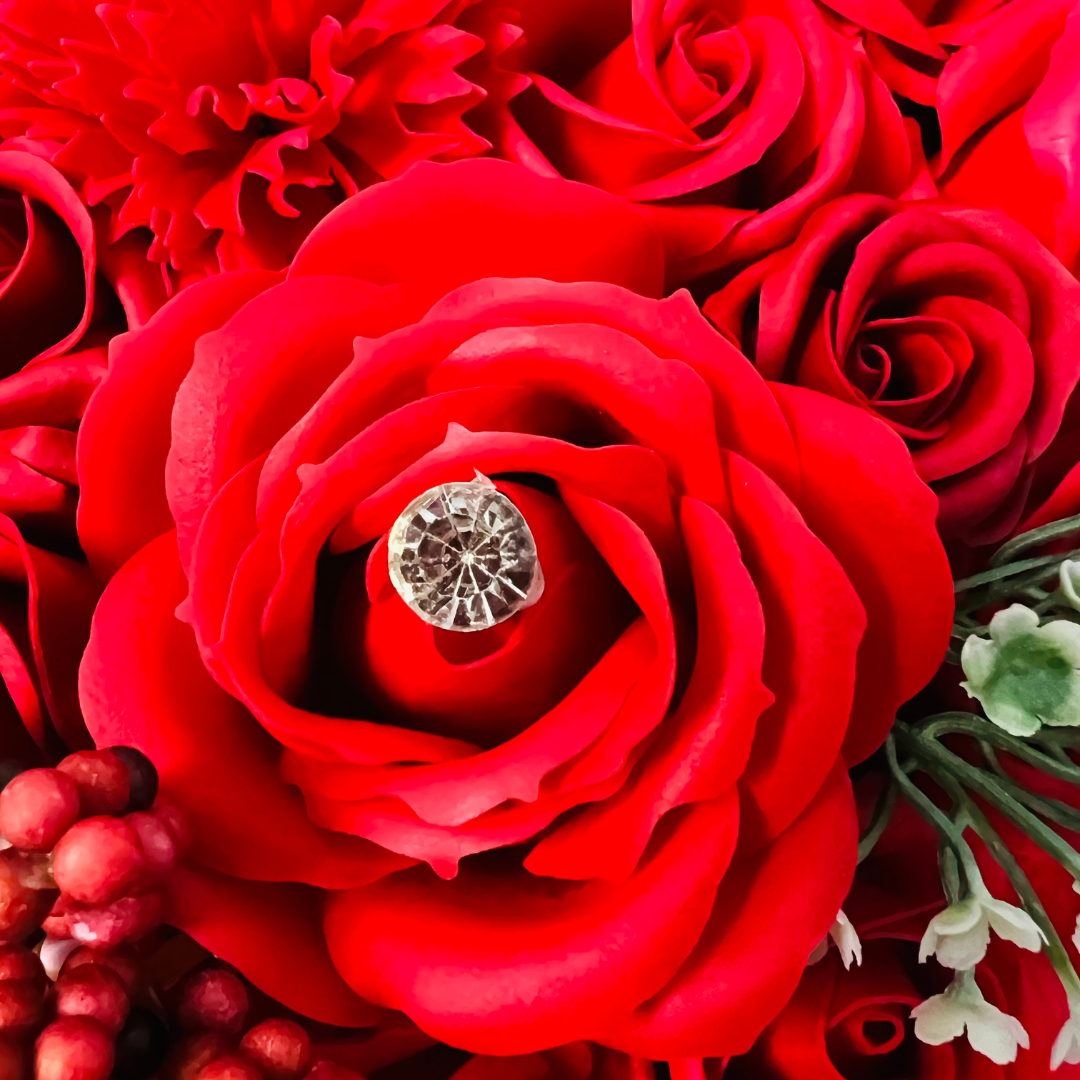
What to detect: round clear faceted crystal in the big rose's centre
<box><xmin>388</xmin><ymin>473</ymin><xmax>543</xmax><ymax>632</ymax></box>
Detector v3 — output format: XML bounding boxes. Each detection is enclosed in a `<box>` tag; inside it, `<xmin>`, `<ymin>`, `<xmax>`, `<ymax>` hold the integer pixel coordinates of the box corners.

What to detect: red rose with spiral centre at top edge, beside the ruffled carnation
<box><xmin>503</xmin><ymin>0</ymin><xmax>921</xmax><ymax>282</ymax></box>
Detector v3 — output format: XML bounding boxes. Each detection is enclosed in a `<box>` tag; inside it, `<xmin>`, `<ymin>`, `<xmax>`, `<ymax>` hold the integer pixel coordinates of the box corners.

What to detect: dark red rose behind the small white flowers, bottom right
<box><xmin>706</xmin><ymin>786</ymin><xmax>1080</xmax><ymax>1080</ymax></box>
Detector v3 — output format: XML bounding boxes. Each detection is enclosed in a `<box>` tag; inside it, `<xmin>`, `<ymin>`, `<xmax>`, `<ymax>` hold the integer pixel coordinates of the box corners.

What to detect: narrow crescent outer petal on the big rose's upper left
<box><xmin>78</xmin><ymin>264</ymin><xmax>276</xmax><ymax>578</ymax></box>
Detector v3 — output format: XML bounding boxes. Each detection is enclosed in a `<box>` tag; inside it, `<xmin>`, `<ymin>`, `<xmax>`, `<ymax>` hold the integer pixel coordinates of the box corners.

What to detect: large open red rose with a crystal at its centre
<box><xmin>79</xmin><ymin>160</ymin><xmax>951</xmax><ymax>1058</ymax></box>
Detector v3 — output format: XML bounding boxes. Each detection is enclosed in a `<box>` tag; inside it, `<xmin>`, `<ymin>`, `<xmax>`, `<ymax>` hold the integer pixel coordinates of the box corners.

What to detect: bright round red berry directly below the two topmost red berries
<box><xmin>51</xmin><ymin>820</ymin><xmax>143</xmax><ymax>904</ymax></box>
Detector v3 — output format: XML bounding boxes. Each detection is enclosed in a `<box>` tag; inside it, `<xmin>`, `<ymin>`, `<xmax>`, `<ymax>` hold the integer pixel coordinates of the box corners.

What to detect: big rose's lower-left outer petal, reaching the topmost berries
<box><xmin>79</xmin><ymin>534</ymin><xmax>408</xmax><ymax>889</ymax></box>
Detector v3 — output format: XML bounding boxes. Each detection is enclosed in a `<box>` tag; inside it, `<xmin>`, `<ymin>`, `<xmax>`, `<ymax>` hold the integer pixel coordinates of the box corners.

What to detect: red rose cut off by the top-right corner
<box><xmin>936</xmin><ymin>0</ymin><xmax>1080</xmax><ymax>272</ymax></box>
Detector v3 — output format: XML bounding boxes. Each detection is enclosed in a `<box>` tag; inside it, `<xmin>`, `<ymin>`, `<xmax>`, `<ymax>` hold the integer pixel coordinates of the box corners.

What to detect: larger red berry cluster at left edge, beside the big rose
<box><xmin>0</xmin><ymin>746</ymin><xmax>186</xmax><ymax>1080</ymax></box>
